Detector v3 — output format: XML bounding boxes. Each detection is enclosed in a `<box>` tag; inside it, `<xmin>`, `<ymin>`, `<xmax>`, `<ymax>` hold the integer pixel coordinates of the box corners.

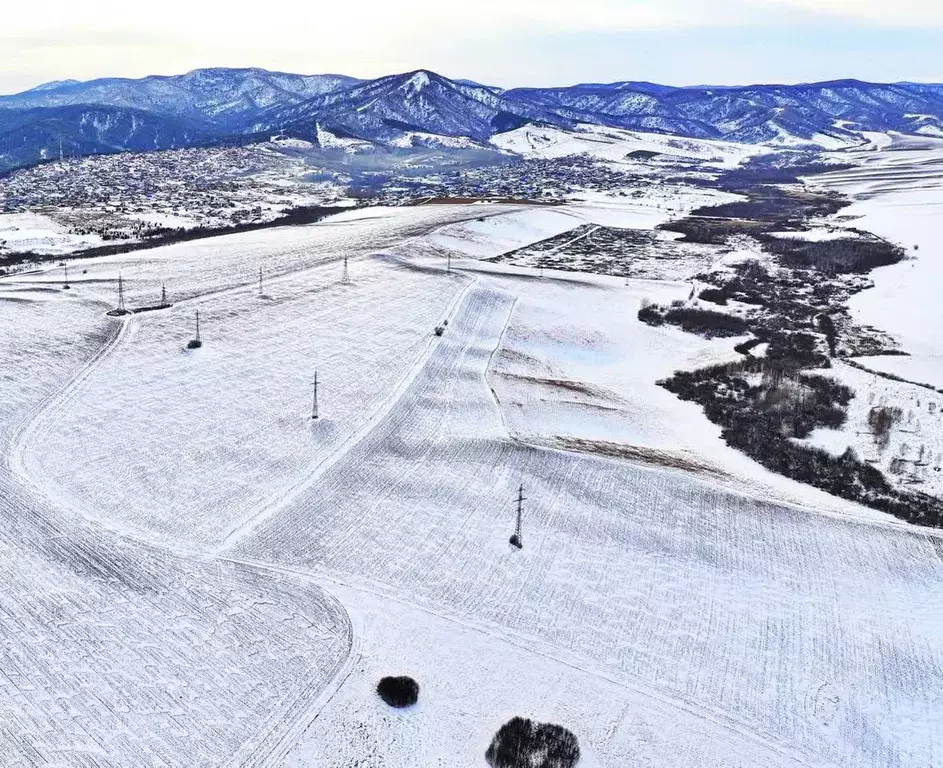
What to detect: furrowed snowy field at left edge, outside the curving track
<box><xmin>0</xmin><ymin>284</ymin><xmax>354</xmax><ymax>766</ymax></box>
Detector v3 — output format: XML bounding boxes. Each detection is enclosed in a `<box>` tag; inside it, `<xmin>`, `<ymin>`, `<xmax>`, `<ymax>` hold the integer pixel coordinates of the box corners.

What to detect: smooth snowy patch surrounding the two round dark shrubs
<box><xmin>286</xmin><ymin>587</ymin><xmax>798</xmax><ymax>768</ymax></box>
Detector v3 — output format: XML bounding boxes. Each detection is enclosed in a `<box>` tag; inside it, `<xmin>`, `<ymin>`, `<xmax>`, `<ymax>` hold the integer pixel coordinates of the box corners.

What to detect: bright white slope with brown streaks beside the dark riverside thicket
<box><xmin>489</xmin><ymin>275</ymin><xmax>877</xmax><ymax>518</ymax></box>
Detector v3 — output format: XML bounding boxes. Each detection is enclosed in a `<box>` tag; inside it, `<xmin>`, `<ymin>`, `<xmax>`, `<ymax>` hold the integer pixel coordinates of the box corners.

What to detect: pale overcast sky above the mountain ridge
<box><xmin>0</xmin><ymin>0</ymin><xmax>943</xmax><ymax>93</ymax></box>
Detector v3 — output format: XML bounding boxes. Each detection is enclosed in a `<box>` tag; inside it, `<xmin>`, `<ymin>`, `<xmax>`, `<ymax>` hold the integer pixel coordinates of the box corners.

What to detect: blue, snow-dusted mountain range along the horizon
<box><xmin>0</xmin><ymin>69</ymin><xmax>943</xmax><ymax>169</ymax></box>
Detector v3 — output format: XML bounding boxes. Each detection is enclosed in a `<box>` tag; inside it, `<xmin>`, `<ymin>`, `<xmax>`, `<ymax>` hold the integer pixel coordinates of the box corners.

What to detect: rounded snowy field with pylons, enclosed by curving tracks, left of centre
<box><xmin>23</xmin><ymin>252</ymin><xmax>462</xmax><ymax>543</ymax></box>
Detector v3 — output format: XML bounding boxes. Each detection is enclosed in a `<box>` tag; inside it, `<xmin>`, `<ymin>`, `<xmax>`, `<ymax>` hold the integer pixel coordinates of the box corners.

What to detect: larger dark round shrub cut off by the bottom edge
<box><xmin>485</xmin><ymin>717</ymin><xmax>580</xmax><ymax>768</ymax></box>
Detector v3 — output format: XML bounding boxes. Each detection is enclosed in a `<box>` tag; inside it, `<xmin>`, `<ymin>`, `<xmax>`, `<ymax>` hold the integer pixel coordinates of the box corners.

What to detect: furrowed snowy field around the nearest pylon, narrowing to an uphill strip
<box><xmin>227</xmin><ymin>288</ymin><xmax>943</xmax><ymax>765</ymax></box>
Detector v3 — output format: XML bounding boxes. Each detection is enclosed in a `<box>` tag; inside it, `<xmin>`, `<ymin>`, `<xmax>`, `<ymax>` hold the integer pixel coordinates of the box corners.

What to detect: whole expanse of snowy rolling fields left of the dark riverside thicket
<box><xmin>0</xmin><ymin>194</ymin><xmax>943</xmax><ymax>768</ymax></box>
